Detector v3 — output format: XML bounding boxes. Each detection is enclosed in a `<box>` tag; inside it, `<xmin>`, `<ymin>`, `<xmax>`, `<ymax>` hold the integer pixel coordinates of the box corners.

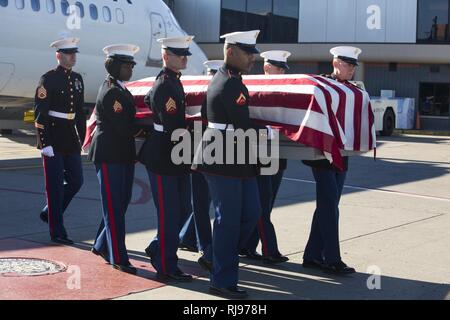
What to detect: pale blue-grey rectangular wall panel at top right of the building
<box><xmin>299</xmin><ymin>0</ymin><xmax>417</xmax><ymax>43</ymax></box>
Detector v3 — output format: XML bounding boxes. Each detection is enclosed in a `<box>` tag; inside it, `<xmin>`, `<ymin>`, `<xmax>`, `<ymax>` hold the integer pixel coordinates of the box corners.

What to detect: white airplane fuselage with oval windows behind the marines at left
<box><xmin>0</xmin><ymin>0</ymin><xmax>207</xmax><ymax>107</ymax></box>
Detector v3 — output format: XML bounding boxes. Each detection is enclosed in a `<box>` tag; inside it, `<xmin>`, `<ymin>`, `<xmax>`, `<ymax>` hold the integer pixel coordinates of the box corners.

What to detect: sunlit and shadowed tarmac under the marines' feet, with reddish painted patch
<box><xmin>0</xmin><ymin>129</ymin><xmax>450</xmax><ymax>301</ymax></box>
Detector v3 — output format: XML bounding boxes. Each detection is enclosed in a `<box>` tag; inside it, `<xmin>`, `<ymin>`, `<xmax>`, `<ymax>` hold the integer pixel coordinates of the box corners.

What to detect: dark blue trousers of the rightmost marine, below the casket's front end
<box><xmin>303</xmin><ymin>167</ymin><xmax>347</xmax><ymax>263</ymax></box>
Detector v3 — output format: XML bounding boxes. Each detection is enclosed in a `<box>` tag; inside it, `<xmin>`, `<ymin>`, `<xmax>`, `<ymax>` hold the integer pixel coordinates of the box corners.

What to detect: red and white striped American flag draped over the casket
<box><xmin>84</xmin><ymin>74</ymin><xmax>376</xmax><ymax>168</ymax></box>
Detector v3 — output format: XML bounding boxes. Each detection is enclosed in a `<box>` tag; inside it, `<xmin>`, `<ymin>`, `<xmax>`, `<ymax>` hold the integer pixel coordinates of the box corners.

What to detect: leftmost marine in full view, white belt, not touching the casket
<box><xmin>34</xmin><ymin>38</ymin><xmax>86</xmax><ymax>244</ymax></box>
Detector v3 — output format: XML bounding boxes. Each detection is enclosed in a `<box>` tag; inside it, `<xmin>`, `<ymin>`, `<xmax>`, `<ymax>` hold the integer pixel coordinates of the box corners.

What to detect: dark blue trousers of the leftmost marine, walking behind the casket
<box><xmin>43</xmin><ymin>152</ymin><xmax>83</xmax><ymax>238</ymax></box>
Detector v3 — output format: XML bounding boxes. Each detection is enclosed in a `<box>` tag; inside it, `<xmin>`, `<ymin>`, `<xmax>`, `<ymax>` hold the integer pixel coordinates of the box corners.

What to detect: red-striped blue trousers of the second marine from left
<box><xmin>94</xmin><ymin>163</ymin><xmax>134</xmax><ymax>265</ymax></box>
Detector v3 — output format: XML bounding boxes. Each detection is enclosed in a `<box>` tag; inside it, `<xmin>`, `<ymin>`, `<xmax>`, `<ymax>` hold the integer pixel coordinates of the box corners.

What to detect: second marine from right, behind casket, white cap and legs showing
<box><xmin>240</xmin><ymin>50</ymin><xmax>291</xmax><ymax>264</ymax></box>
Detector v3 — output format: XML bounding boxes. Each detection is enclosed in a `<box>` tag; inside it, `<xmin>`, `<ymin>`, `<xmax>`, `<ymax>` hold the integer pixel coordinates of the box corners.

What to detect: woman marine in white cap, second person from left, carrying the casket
<box><xmin>89</xmin><ymin>44</ymin><xmax>139</xmax><ymax>274</ymax></box>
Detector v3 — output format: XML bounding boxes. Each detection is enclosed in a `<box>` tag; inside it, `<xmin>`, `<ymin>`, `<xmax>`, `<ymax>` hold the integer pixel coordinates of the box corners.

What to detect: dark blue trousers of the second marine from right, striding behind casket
<box><xmin>246</xmin><ymin>170</ymin><xmax>284</xmax><ymax>256</ymax></box>
